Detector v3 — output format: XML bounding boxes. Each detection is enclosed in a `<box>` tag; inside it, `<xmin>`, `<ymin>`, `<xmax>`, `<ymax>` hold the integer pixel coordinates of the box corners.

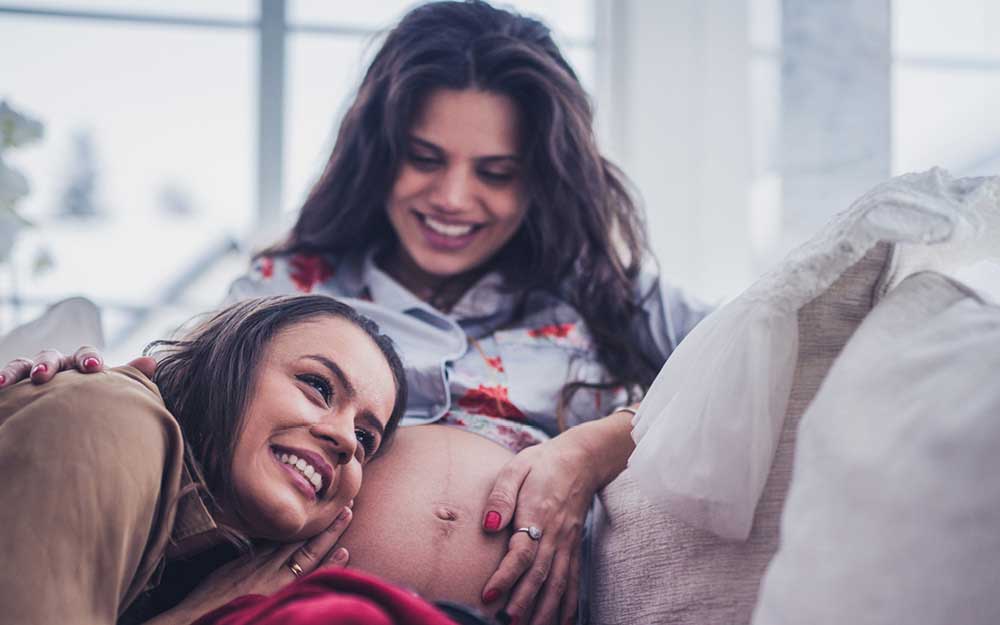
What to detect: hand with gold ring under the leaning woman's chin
<box><xmin>153</xmin><ymin>508</ymin><xmax>352</xmax><ymax>623</ymax></box>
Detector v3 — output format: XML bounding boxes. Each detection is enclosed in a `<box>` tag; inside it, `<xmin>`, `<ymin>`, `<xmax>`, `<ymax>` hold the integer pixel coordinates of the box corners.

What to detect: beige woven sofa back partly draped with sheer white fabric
<box><xmin>591</xmin><ymin>243</ymin><xmax>892</xmax><ymax>625</ymax></box>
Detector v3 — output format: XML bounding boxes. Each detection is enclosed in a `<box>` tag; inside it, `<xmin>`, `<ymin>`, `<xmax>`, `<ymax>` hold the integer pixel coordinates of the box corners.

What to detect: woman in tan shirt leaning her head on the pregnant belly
<box><xmin>0</xmin><ymin>296</ymin><xmax>422</xmax><ymax>624</ymax></box>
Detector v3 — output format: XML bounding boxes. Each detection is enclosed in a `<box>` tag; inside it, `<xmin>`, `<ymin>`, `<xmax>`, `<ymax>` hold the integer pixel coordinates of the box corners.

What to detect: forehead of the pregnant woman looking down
<box><xmin>411</xmin><ymin>89</ymin><xmax>520</xmax><ymax>156</ymax></box>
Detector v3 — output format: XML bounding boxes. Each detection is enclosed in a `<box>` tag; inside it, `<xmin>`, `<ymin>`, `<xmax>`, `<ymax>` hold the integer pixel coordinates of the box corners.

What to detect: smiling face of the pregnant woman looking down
<box><xmin>388</xmin><ymin>89</ymin><xmax>525</xmax><ymax>289</ymax></box>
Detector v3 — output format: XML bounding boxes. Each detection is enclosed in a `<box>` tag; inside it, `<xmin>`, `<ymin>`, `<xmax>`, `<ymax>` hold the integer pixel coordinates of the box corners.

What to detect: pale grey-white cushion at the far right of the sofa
<box><xmin>754</xmin><ymin>273</ymin><xmax>1000</xmax><ymax>625</ymax></box>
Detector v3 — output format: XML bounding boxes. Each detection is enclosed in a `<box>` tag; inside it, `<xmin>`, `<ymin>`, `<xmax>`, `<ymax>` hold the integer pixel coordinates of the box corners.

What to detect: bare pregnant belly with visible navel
<box><xmin>339</xmin><ymin>425</ymin><xmax>513</xmax><ymax>609</ymax></box>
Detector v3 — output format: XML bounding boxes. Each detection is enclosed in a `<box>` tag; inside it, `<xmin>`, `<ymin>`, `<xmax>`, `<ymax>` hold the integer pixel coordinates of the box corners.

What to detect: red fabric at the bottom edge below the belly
<box><xmin>193</xmin><ymin>568</ymin><xmax>455</xmax><ymax>625</ymax></box>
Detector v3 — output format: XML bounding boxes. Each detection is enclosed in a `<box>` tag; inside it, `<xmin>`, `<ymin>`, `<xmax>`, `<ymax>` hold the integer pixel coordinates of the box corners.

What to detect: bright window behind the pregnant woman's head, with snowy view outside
<box><xmin>0</xmin><ymin>0</ymin><xmax>596</xmax><ymax>362</ymax></box>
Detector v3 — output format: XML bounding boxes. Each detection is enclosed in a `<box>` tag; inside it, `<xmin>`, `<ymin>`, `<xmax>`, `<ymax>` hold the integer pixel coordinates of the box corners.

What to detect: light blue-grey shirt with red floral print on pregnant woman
<box><xmin>227</xmin><ymin>253</ymin><xmax>708</xmax><ymax>452</ymax></box>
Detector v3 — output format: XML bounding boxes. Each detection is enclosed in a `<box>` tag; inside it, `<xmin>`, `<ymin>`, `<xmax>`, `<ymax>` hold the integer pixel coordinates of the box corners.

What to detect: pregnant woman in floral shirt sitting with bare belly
<box><xmin>0</xmin><ymin>1</ymin><xmax>707</xmax><ymax>623</ymax></box>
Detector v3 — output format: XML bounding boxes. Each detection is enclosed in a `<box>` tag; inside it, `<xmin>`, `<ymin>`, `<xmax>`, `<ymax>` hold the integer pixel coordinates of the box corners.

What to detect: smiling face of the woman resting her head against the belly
<box><xmin>224</xmin><ymin>316</ymin><xmax>396</xmax><ymax>542</ymax></box>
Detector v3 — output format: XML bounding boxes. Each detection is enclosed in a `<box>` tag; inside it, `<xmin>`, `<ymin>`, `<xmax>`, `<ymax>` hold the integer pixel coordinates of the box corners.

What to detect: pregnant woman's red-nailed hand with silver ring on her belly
<box><xmin>483</xmin><ymin>413</ymin><xmax>634</xmax><ymax>625</ymax></box>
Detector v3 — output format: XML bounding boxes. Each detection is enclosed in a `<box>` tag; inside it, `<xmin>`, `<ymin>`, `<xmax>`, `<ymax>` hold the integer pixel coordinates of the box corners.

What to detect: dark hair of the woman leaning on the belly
<box><xmin>144</xmin><ymin>295</ymin><xmax>407</xmax><ymax>524</ymax></box>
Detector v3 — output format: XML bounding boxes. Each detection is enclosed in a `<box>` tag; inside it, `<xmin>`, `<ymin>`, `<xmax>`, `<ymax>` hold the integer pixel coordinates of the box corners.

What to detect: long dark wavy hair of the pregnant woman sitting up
<box><xmin>274</xmin><ymin>1</ymin><xmax>662</xmax><ymax>417</ymax></box>
